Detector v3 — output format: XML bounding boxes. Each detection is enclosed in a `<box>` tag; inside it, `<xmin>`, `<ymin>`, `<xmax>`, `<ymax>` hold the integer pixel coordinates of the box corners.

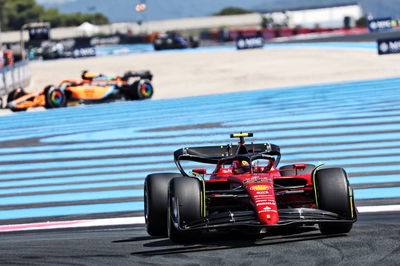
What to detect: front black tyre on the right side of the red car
<box><xmin>313</xmin><ymin>168</ymin><xmax>356</xmax><ymax>234</ymax></box>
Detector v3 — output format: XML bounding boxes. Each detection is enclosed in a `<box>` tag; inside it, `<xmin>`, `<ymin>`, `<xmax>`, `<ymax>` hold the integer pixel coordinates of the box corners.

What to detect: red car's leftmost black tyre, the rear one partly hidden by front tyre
<box><xmin>144</xmin><ymin>173</ymin><xmax>181</xmax><ymax>236</ymax></box>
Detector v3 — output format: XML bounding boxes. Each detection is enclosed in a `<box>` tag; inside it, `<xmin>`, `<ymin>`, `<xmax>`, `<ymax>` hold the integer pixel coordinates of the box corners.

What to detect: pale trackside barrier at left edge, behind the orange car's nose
<box><xmin>0</xmin><ymin>61</ymin><xmax>31</xmax><ymax>97</ymax></box>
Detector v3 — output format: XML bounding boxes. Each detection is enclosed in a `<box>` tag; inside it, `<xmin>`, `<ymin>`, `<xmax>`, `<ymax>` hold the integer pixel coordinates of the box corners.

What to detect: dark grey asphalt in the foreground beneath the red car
<box><xmin>0</xmin><ymin>212</ymin><xmax>400</xmax><ymax>265</ymax></box>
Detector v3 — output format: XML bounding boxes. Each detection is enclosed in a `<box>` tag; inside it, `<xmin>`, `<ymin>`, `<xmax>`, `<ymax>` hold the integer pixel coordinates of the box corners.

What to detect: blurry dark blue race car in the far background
<box><xmin>153</xmin><ymin>32</ymin><xmax>199</xmax><ymax>50</ymax></box>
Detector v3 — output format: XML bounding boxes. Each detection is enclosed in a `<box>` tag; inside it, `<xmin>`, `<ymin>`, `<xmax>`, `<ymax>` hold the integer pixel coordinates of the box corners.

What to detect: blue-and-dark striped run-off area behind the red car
<box><xmin>0</xmin><ymin>75</ymin><xmax>400</xmax><ymax>225</ymax></box>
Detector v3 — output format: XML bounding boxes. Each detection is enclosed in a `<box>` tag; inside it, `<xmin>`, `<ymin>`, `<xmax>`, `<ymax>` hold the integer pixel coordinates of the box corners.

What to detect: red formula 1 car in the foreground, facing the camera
<box><xmin>144</xmin><ymin>133</ymin><xmax>357</xmax><ymax>242</ymax></box>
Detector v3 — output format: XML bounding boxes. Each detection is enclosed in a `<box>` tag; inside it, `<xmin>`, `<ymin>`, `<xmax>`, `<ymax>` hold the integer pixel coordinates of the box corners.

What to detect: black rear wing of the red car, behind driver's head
<box><xmin>174</xmin><ymin>143</ymin><xmax>281</xmax><ymax>175</ymax></box>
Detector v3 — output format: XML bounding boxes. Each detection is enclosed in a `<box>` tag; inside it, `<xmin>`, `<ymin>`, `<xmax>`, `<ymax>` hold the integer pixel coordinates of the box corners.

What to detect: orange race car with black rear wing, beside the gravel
<box><xmin>7</xmin><ymin>71</ymin><xmax>154</xmax><ymax>112</ymax></box>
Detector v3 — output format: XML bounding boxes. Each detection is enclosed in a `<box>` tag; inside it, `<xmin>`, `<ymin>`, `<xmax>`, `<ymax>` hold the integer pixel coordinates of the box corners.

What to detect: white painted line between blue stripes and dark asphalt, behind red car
<box><xmin>0</xmin><ymin>205</ymin><xmax>400</xmax><ymax>232</ymax></box>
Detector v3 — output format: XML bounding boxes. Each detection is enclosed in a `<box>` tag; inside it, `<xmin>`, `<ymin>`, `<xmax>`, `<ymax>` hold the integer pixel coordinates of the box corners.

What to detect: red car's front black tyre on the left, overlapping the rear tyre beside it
<box><xmin>168</xmin><ymin>177</ymin><xmax>202</xmax><ymax>243</ymax></box>
